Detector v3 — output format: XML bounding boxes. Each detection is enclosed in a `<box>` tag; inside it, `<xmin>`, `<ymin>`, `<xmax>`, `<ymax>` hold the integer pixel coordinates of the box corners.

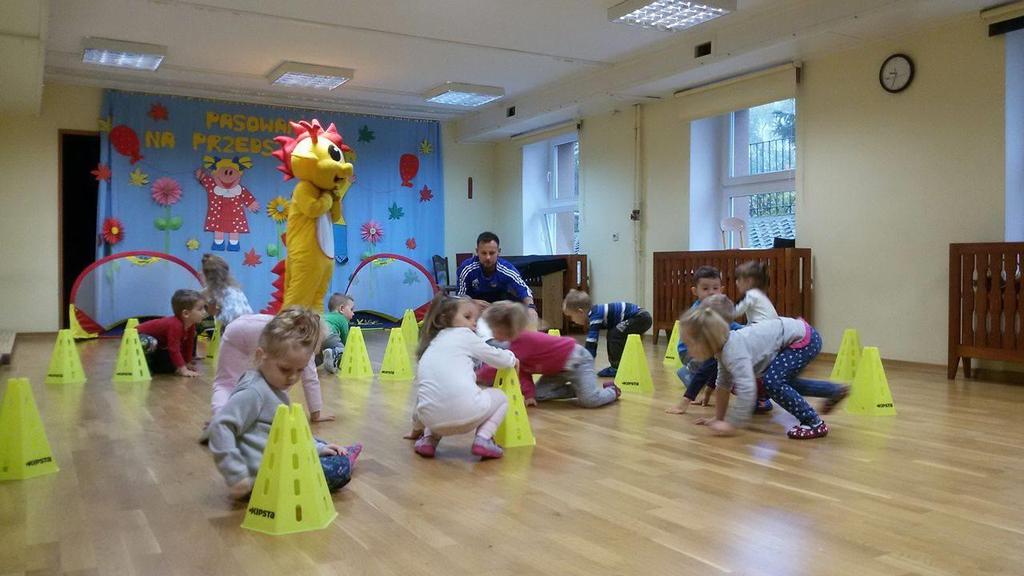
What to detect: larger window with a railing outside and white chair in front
<box><xmin>690</xmin><ymin>98</ymin><xmax>797</xmax><ymax>250</ymax></box>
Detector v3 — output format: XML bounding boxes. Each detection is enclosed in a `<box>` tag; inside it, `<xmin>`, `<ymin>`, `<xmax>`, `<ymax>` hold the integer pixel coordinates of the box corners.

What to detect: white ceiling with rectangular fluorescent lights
<box><xmin>12</xmin><ymin>0</ymin><xmax>999</xmax><ymax>135</ymax></box>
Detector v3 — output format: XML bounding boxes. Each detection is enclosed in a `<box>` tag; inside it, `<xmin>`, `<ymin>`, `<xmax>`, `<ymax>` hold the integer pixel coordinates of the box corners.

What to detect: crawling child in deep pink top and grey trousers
<box><xmin>477</xmin><ymin>301</ymin><xmax>622</xmax><ymax>408</ymax></box>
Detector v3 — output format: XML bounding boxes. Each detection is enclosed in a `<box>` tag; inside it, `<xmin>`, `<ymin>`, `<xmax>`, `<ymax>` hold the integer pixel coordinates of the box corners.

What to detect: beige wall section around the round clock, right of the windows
<box><xmin>797</xmin><ymin>18</ymin><xmax>1005</xmax><ymax>363</ymax></box>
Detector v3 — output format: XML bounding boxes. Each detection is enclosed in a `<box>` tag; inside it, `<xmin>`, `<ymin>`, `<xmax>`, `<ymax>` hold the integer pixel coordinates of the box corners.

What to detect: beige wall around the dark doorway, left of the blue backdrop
<box><xmin>0</xmin><ymin>85</ymin><xmax>102</xmax><ymax>332</ymax></box>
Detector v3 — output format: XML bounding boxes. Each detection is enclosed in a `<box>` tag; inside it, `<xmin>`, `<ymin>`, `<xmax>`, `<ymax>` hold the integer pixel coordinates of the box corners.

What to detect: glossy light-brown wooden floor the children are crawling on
<box><xmin>0</xmin><ymin>333</ymin><xmax>1024</xmax><ymax>576</ymax></box>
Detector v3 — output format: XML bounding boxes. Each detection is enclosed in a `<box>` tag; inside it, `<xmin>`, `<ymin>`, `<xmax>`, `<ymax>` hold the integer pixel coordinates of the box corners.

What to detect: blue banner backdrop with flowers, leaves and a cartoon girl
<box><xmin>94</xmin><ymin>90</ymin><xmax>444</xmax><ymax>314</ymax></box>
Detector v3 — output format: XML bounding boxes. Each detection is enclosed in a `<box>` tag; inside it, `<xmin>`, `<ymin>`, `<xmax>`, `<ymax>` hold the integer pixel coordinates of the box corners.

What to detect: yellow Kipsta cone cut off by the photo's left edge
<box><xmin>0</xmin><ymin>378</ymin><xmax>59</xmax><ymax>480</ymax></box>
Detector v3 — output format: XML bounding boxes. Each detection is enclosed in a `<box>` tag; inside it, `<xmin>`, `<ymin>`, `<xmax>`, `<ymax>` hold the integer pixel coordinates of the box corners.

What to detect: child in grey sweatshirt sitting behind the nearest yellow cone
<box><xmin>210</xmin><ymin>307</ymin><xmax>362</xmax><ymax>498</ymax></box>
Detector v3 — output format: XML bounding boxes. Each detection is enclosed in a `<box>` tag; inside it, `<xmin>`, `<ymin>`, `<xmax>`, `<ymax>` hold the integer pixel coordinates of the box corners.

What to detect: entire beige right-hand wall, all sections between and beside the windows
<box><xmin>496</xmin><ymin>16</ymin><xmax>1005</xmax><ymax>363</ymax></box>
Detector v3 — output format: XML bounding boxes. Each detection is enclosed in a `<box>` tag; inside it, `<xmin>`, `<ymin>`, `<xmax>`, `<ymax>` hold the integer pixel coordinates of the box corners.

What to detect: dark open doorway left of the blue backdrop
<box><xmin>57</xmin><ymin>130</ymin><xmax>99</xmax><ymax>327</ymax></box>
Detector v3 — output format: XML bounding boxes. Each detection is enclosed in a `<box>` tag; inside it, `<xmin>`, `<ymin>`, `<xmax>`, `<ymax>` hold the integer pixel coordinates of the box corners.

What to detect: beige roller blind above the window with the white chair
<box><xmin>675</xmin><ymin>64</ymin><xmax>800</xmax><ymax>120</ymax></box>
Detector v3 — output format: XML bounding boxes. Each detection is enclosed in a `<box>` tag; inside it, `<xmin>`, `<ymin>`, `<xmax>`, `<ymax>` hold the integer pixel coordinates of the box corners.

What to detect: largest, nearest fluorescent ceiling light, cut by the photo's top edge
<box><xmin>608</xmin><ymin>0</ymin><xmax>736</xmax><ymax>31</ymax></box>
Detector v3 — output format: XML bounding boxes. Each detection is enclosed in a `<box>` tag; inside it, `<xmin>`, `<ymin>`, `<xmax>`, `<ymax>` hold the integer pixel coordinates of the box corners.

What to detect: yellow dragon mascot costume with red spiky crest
<box><xmin>273</xmin><ymin>120</ymin><xmax>353</xmax><ymax>314</ymax></box>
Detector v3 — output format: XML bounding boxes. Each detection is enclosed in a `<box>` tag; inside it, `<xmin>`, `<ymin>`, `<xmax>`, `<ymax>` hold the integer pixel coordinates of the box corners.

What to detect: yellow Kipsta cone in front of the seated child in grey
<box><xmin>242</xmin><ymin>404</ymin><xmax>338</xmax><ymax>536</ymax></box>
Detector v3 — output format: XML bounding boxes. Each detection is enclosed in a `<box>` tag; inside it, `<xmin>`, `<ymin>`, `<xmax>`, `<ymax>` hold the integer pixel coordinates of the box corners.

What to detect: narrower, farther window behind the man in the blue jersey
<box><xmin>522</xmin><ymin>132</ymin><xmax>580</xmax><ymax>254</ymax></box>
